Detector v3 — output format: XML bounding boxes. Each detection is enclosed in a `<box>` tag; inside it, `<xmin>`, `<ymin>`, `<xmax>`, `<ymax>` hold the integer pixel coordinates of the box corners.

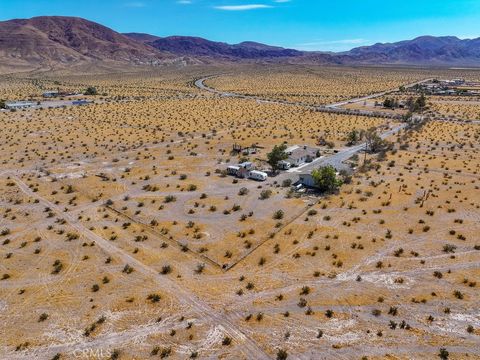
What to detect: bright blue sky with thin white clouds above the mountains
<box><xmin>0</xmin><ymin>0</ymin><xmax>480</xmax><ymax>51</ymax></box>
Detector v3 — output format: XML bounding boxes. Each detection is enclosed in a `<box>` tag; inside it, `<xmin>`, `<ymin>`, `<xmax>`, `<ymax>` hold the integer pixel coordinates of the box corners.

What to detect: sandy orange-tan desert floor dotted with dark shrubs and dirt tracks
<box><xmin>0</xmin><ymin>65</ymin><xmax>480</xmax><ymax>359</ymax></box>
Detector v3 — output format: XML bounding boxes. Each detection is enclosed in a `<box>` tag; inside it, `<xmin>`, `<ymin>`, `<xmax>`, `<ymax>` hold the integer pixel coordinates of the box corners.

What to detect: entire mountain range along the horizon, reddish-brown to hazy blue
<box><xmin>0</xmin><ymin>16</ymin><xmax>480</xmax><ymax>69</ymax></box>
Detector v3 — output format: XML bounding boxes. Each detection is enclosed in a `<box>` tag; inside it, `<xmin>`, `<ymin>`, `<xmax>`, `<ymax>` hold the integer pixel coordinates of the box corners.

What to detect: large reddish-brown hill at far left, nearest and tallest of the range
<box><xmin>0</xmin><ymin>16</ymin><xmax>172</xmax><ymax>67</ymax></box>
